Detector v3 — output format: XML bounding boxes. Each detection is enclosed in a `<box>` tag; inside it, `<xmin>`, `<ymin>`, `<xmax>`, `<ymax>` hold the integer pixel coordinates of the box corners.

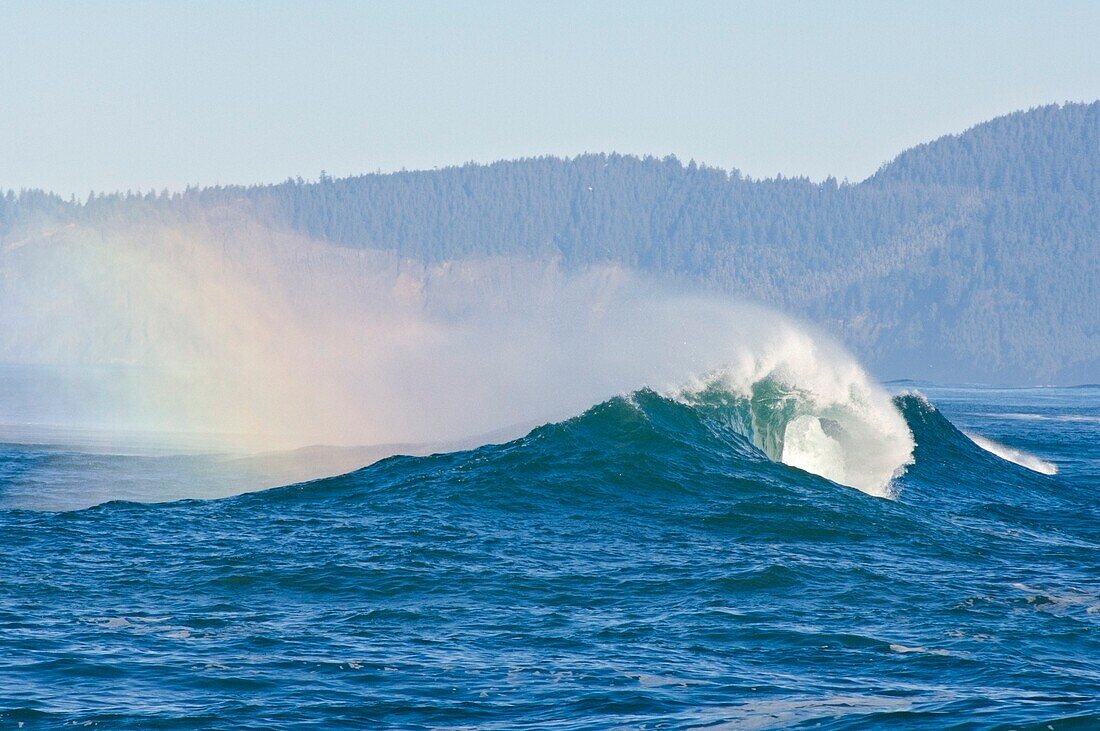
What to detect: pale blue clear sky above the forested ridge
<box><xmin>0</xmin><ymin>0</ymin><xmax>1100</xmax><ymax>196</ymax></box>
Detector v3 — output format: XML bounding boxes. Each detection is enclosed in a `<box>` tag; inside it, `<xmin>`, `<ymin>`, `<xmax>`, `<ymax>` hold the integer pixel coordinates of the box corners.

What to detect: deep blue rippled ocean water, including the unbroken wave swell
<box><xmin>0</xmin><ymin>384</ymin><xmax>1100</xmax><ymax>730</ymax></box>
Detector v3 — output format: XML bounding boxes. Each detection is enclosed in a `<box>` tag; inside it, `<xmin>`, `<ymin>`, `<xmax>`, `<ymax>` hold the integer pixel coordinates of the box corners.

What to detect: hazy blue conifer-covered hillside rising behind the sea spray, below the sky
<box><xmin>0</xmin><ymin>102</ymin><xmax>1100</xmax><ymax>384</ymax></box>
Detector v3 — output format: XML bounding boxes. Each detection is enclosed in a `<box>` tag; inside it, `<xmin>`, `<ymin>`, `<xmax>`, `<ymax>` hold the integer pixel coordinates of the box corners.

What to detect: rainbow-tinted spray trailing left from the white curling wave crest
<box><xmin>0</xmin><ymin>214</ymin><xmax>912</xmax><ymax>492</ymax></box>
